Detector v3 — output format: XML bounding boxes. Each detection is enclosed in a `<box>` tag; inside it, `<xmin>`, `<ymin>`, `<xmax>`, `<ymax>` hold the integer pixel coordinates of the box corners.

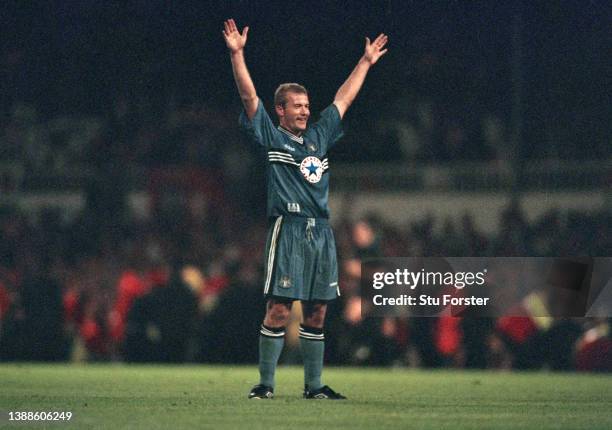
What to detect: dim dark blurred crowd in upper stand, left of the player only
<box><xmin>0</xmin><ymin>97</ymin><xmax>249</xmax><ymax>185</ymax></box>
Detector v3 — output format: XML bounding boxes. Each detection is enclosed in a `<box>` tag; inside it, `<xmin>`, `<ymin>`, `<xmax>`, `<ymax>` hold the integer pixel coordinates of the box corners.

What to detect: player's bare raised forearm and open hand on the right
<box><xmin>334</xmin><ymin>33</ymin><xmax>389</xmax><ymax>118</ymax></box>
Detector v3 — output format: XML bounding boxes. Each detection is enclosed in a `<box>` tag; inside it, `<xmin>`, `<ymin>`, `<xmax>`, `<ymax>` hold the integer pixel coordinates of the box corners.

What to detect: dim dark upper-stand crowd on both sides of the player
<box><xmin>0</xmin><ymin>89</ymin><xmax>612</xmax><ymax>191</ymax></box>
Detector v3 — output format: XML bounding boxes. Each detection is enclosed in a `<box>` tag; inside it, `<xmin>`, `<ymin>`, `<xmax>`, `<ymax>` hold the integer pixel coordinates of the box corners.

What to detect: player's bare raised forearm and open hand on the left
<box><xmin>223</xmin><ymin>19</ymin><xmax>259</xmax><ymax>119</ymax></box>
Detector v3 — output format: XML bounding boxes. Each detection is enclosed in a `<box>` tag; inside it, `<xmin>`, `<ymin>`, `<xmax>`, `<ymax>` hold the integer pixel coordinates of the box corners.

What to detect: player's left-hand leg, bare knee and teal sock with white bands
<box><xmin>249</xmin><ymin>297</ymin><xmax>292</xmax><ymax>398</ymax></box>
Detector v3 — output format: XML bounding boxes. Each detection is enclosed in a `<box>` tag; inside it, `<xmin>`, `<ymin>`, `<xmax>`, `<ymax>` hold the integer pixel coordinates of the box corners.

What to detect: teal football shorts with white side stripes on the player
<box><xmin>264</xmin><ymin>215</ymin><xmax>340</xmax><ymax>301</ymax></box>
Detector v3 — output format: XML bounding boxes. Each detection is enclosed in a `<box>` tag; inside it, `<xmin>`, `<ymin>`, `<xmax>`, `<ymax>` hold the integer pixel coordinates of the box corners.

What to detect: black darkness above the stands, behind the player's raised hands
<box><xmin>0</xmin><ymin>0</ymin><xmax>612</xmax><ymax>156</ymax></box>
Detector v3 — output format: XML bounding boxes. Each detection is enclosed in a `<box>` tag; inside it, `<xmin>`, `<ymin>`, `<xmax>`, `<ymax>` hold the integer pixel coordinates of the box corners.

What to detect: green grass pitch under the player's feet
<box><xmin>0</xmin><ymin>364</ymin><xmax>612</xmax><ymax>430</ymax></box>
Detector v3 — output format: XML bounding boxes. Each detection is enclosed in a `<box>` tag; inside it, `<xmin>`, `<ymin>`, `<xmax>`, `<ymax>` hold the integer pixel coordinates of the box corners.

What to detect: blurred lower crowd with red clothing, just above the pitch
<box><xmin>0</xmin><ymin>197</ymin><xmax>612</xmax><ymax>371</ymax></box>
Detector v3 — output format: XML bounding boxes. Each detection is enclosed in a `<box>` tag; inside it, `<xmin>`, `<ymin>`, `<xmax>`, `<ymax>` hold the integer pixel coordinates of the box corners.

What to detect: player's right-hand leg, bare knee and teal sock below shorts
<box><xmin>300</xmin><ymin>302</ymin><xmax>327</xmax><ymax>390</ymax></box>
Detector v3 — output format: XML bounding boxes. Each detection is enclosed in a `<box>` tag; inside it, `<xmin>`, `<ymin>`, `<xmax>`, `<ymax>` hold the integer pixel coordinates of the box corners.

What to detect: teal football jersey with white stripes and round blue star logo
<box><xmin>240</xmin><ymin>100</ymin><xmax>343</xmax><ymax>218</ymax></box>
